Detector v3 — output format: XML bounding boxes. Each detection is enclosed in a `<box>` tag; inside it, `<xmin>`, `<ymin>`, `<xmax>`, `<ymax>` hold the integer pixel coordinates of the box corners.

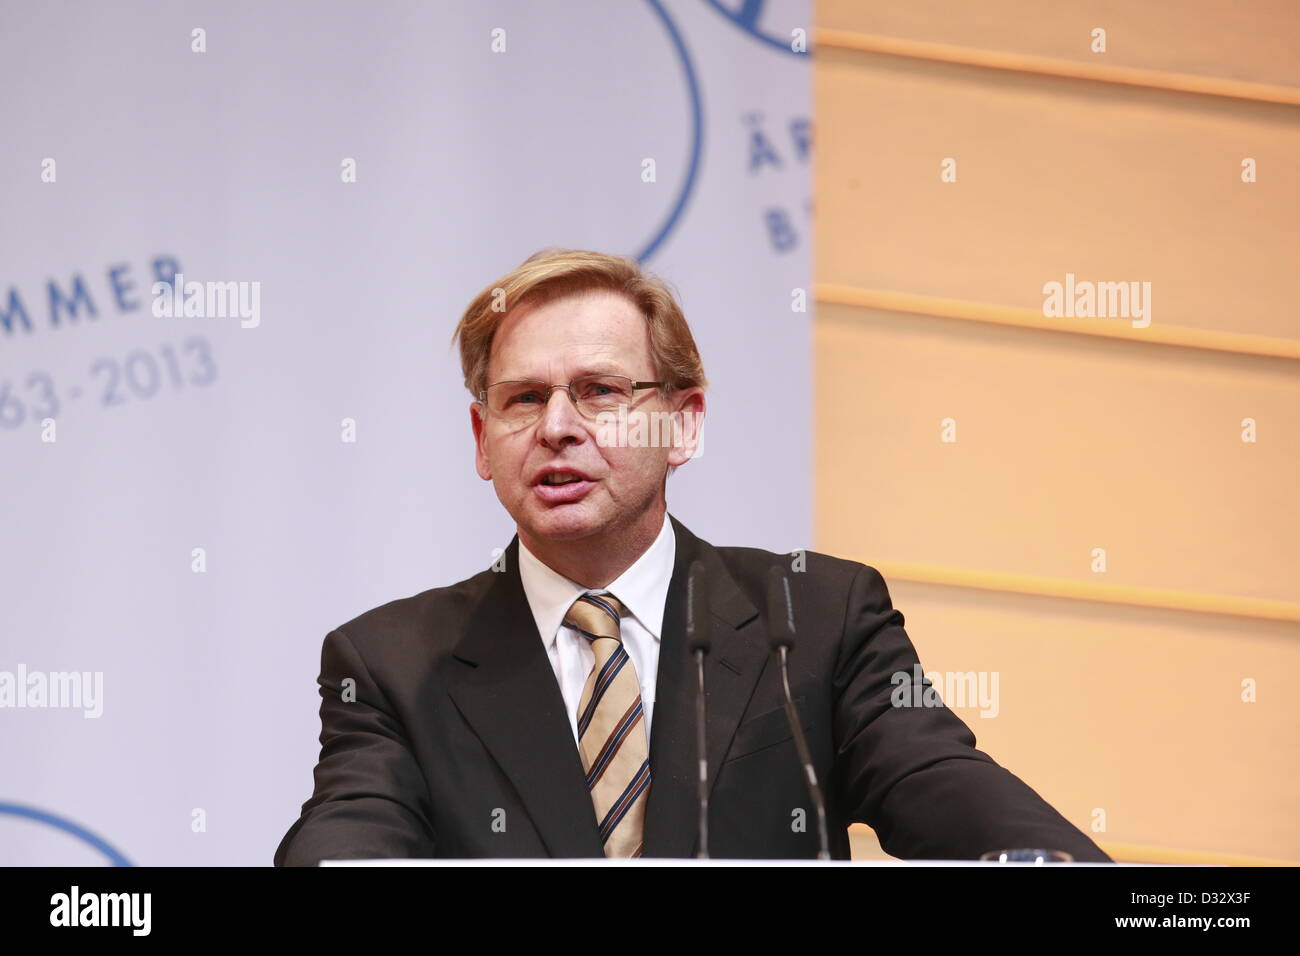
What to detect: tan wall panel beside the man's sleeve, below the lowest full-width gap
<box><xmin>842</xmin><ymin>583</ymin><xmax>1300</xmax><ymax>860</ymax></box>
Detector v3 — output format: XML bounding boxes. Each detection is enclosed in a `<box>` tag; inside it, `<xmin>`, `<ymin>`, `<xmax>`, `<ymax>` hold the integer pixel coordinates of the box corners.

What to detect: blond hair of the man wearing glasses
<box><xmin>451</xmin><ymin>248</ymin><xmax>709</xmax><ymax>398</ymax></box>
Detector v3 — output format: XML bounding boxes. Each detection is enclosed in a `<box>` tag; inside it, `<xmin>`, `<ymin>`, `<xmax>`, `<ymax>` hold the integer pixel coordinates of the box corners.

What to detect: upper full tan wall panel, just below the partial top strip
<box><xmin>814</xmin><ymin>52</ymin><xmax>1300</xmax><ymax>338</ymax></box>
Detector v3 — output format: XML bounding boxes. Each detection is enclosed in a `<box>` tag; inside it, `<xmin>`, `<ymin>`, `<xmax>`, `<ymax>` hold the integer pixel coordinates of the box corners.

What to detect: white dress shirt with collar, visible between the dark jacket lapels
<box><xmin>519</xmin><ymin>511</ymin><xmax>677</xmax><ymax>745</ymax></box>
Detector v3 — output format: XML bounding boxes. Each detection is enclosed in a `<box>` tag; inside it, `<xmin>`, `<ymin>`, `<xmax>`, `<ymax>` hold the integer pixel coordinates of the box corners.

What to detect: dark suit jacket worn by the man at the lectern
<box><xmin>276</xmin><ymin>518</ymin><xmax>1109</xmax><ymax>865</ymax></box>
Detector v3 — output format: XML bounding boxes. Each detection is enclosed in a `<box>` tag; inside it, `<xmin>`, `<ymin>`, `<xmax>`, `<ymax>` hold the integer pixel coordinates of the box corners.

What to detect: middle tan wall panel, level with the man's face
<box><xmin>814</xmin><ymin>306</ymin><xmax>1300</xmax><ymax>602</ymax></box>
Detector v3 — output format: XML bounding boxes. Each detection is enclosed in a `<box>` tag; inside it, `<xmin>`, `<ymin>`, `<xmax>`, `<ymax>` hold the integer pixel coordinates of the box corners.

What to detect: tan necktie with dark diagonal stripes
<box><xmin>564</xmin><ymin>594</ymin><xmax>650</xmax><ymax>857</ymax></box>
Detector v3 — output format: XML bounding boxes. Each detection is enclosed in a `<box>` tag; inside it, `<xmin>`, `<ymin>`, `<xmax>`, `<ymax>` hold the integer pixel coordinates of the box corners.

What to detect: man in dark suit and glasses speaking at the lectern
<box><xmin>276</xmin><ymin>251</ymin><xmax>1109</xmax><ymax>865</ymax></box>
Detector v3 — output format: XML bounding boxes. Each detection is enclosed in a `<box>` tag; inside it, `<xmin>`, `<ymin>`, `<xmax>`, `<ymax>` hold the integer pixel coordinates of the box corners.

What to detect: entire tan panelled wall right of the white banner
<box><xmin>814</xmin><ymin>0</ymin><xmax>1300</xmax><ymax>861</ymax></box>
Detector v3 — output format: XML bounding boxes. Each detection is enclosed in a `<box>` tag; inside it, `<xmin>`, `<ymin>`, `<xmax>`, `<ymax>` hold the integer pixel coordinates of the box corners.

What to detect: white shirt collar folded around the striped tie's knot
<box><xmin>519</xmin><ymin>511</ymin><xmax>677</xmax><ymax>648</ymax></box>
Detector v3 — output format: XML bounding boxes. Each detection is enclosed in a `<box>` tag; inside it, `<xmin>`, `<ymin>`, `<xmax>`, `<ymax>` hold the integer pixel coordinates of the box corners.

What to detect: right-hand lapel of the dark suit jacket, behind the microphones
<box><xmin>644</xmin><ymin>515</ymin><xmax>768</xmax><ymax>857</ymax></box>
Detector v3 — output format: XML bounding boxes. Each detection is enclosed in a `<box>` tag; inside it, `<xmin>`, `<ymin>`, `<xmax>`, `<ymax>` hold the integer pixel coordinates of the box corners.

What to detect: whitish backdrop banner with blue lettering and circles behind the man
<box><xmin>0</xmin><ymin>0</ymin><xmax>811</xmax><ymax>865</ymax></box>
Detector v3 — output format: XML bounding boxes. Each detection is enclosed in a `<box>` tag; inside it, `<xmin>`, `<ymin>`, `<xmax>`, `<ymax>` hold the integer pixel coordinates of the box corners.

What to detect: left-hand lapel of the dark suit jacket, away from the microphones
<box><xmin>447</xmin><ymin>536</ymin><xmax>605</xmax><ymax>857</ymax></box>
